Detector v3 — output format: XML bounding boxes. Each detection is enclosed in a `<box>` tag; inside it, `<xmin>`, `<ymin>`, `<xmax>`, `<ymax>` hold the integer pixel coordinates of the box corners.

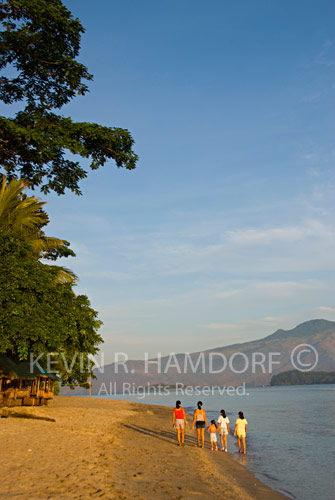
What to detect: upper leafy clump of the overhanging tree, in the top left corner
<box><xmin>0</xmin><ymin>0</ymin><xmax>92</xmax><ymax>108</ymax></box>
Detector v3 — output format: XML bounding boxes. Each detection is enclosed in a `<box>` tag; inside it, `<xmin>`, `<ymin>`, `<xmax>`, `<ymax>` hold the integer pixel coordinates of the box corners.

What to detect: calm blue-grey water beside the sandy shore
<box><xmin>93</xmin><ymin>385</ymin><xmax>335</xmax><ymax>500</ymax></box>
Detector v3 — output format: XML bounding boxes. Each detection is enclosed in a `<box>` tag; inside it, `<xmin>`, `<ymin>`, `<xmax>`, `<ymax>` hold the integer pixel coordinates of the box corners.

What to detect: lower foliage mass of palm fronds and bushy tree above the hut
<box><xmin>0</xmin><ymin>176</ymin><xmax>102</xmax><ymax>386</ymax></box>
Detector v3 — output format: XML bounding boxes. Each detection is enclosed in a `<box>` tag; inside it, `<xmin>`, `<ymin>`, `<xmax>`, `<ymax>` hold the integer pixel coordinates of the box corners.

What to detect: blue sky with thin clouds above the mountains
<box><xmin>15</xmin><ymin>0</ymin><xmax>335</xmax><ymax>362</ymax></box>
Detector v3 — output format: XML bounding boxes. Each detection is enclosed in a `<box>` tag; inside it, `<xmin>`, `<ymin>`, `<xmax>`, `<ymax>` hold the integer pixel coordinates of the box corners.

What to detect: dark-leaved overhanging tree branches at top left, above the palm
<box><xmin>0</xmin><ymin>0</ymin><xmax>138</xmax><ymax>194</ymax></box>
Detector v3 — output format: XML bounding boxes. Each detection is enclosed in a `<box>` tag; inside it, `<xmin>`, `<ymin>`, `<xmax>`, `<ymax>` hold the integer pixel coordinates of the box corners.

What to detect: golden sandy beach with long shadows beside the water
<box><xmin>0</xmin><ymin>396</ymin><xmax>286</xmax><ymax>500</ymax></box>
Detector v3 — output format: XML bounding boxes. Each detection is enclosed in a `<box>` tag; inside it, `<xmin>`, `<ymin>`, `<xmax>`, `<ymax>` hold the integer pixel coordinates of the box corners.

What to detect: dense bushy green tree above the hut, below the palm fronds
<box><xmin>0</xmin><ymin>229</ymin><xmax>102</xmax><ymax>386</ymax></box>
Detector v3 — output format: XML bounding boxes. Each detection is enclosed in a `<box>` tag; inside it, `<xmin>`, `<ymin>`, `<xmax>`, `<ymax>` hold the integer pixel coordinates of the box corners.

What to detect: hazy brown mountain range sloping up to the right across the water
<box><xmin>62</xmin><ymin>319</ymin><xmax>335</xmax><ymax>394</ymax></box>
